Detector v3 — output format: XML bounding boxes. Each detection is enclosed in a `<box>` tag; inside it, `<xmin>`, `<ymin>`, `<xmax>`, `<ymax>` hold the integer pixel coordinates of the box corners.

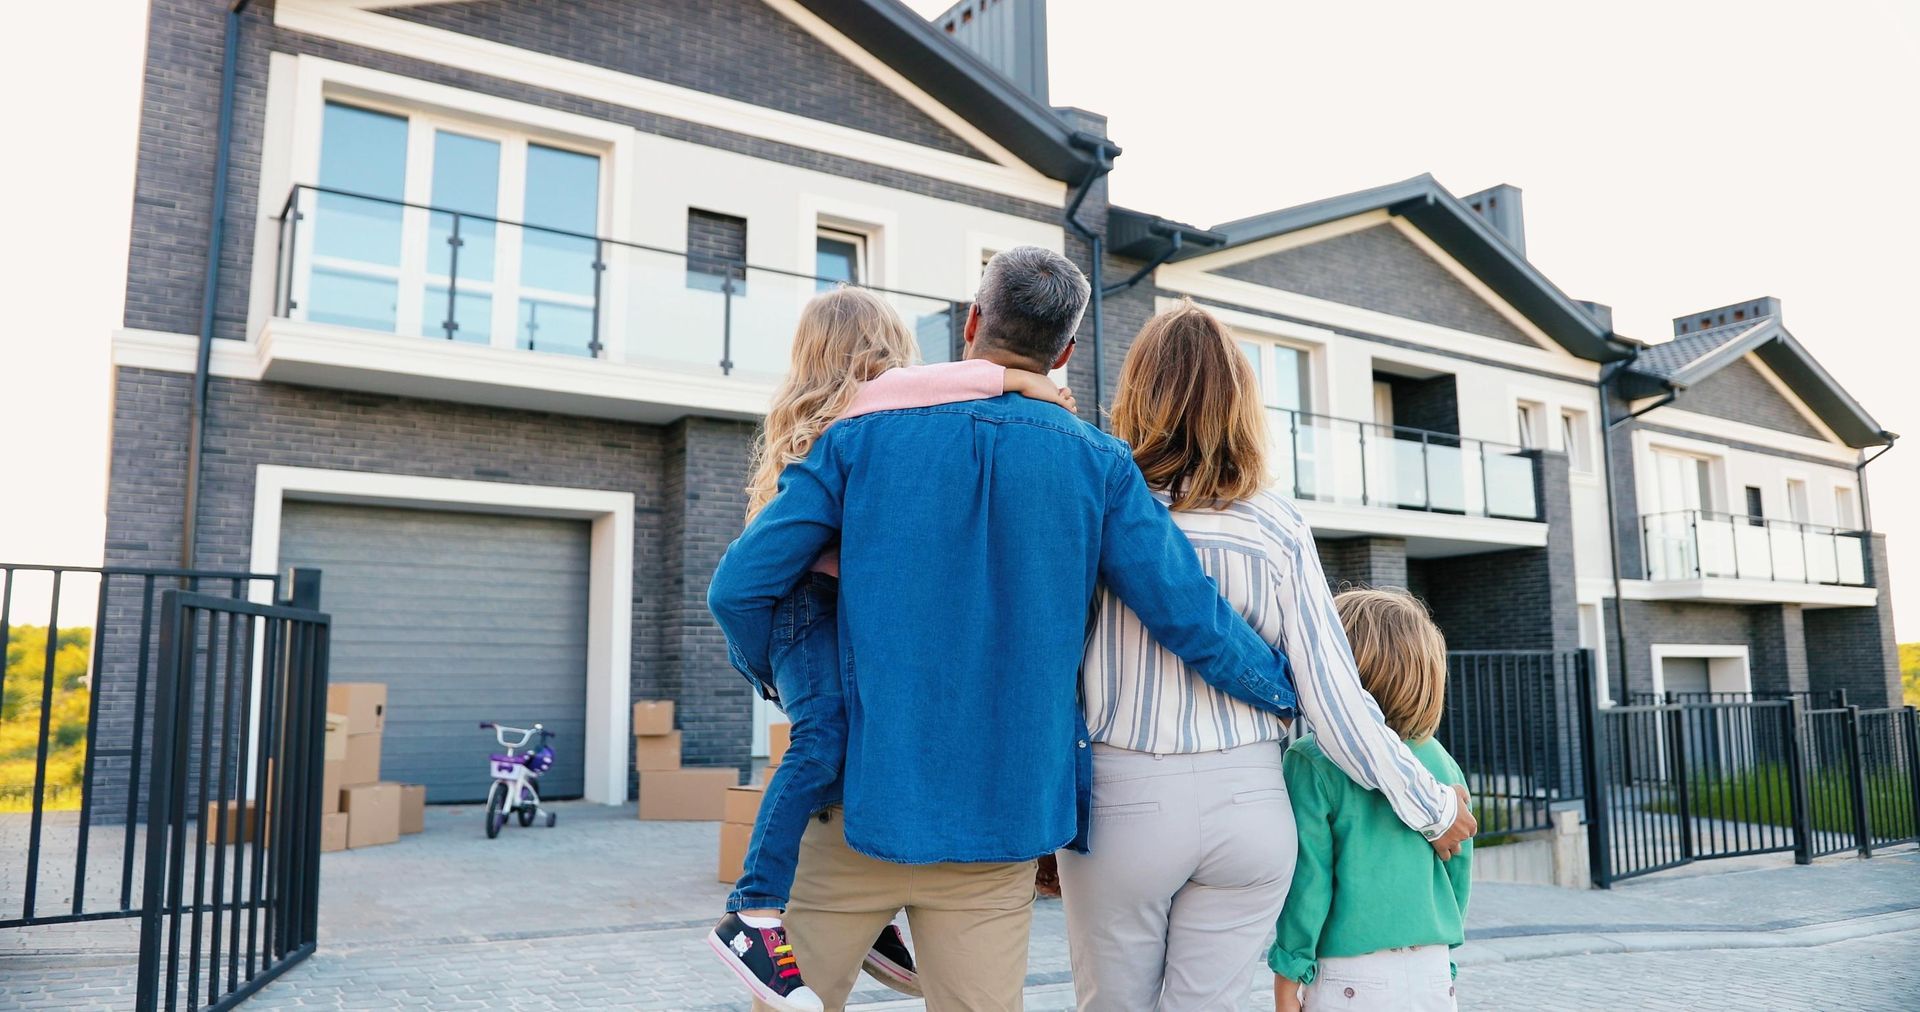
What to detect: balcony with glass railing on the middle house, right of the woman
<box><xmin>1267</xmin><ymin>407</ymin><xmax>1546</xmax><ymax>557</ymax></box>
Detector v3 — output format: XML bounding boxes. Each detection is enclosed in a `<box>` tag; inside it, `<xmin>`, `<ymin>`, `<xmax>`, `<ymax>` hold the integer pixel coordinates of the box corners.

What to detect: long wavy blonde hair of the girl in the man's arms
<box><xmin>747</xmin><ymin>288</ymin><xmax>916</xmax><ymax>520</ymax></box>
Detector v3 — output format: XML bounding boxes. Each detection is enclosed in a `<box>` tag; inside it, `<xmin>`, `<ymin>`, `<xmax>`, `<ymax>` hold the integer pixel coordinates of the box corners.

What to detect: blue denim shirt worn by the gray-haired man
<box><xmin>707</xmin><ymin>394</ymin><xmax>1294</xmax><ymax>864</ymax></box>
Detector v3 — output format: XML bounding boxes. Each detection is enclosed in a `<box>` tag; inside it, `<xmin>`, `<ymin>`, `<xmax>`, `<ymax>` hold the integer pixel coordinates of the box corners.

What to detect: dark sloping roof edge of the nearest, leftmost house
<box><xmin>797</xmin><ymin>0</ymin><xmax>1119</xmax><ymax>182</ymax></box>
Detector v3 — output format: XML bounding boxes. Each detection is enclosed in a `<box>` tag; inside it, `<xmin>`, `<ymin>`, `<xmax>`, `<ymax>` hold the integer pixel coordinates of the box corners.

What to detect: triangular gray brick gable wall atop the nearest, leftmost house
<box><xmin>382</xmin><ymin>0</ymin><xmax>985</xmax><ymax>157</ymax></box>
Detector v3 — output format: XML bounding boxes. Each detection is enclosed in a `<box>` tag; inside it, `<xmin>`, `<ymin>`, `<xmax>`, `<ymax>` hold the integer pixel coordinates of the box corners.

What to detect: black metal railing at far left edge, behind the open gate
<box><xmin>0</xmin><ymin>565</ymin><xmax>280</xmax><ymax>929</ymax></box>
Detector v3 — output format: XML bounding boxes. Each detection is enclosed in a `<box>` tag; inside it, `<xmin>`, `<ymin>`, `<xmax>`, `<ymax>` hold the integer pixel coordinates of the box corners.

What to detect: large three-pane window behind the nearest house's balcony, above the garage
<box><xmin>296</xmin><ymin>102</ymin><xmax>601</xmax><ymax>355</ymax></box>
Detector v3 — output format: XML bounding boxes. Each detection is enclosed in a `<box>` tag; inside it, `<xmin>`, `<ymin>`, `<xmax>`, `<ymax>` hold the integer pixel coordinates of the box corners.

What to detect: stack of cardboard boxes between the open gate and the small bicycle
<box><xmin>321</xmin><ymin>682</ymin><xmax>426</xmax><ymax>851</ymax></box>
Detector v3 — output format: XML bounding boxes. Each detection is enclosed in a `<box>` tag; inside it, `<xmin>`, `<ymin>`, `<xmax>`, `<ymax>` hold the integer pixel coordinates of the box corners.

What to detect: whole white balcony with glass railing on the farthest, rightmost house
<box><xmin>1640</xmin><ymin>509</ymin><xmax>1878</xmax><ymax>607</ymax></box>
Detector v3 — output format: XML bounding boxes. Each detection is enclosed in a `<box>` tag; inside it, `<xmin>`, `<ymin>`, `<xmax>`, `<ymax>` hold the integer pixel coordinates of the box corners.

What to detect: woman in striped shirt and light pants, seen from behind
<box><xmin>1058</xmin><ymin>303</ymin><xmax>1471</xmax><ymax>1012</ymax></box>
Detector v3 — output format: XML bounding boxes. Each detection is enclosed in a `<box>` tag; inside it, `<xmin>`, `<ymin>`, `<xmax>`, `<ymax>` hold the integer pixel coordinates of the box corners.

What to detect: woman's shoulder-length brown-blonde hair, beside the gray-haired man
<box><xmin>1114</xmin><ymin>301</ymin><xmax>1267</xmax><ymax>509</ymax></box>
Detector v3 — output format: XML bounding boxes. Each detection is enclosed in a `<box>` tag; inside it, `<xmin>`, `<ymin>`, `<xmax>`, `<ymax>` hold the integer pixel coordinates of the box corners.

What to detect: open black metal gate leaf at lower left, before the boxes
<box><xmin>138</xmin><ymin>582</ymin><xmax>328</xmax><ymax>1012</ymax></box>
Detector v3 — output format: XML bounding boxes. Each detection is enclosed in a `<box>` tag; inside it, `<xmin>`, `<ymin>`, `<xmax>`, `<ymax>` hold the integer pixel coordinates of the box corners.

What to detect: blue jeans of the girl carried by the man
<box><xmin>726</xmin><ymin>572</ymin><xmax>847</xmax><ymax>910</ymax></box>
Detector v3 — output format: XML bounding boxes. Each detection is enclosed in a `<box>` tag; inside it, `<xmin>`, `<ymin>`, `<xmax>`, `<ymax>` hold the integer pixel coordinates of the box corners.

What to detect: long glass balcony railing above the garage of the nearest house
<box><xmin>275</xmin><ymin>184</ymin><xmax>966</xmax><ymax>376</ymax></box>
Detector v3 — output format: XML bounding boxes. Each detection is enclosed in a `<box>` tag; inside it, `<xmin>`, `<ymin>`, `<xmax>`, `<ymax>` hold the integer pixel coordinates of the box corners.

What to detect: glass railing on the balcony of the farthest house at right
<box><xmin>1640</xmin><ymin>509</ymin><xmax>1868</xmax><ymax>588</ymax></box>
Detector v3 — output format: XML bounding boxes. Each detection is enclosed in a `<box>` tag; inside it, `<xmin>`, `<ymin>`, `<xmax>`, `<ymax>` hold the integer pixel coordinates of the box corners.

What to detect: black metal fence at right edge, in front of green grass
<box><xmin>1582</xmin><ymin>693</ymin><xmax>1920</xmax><ymax>887</ymax></box>
